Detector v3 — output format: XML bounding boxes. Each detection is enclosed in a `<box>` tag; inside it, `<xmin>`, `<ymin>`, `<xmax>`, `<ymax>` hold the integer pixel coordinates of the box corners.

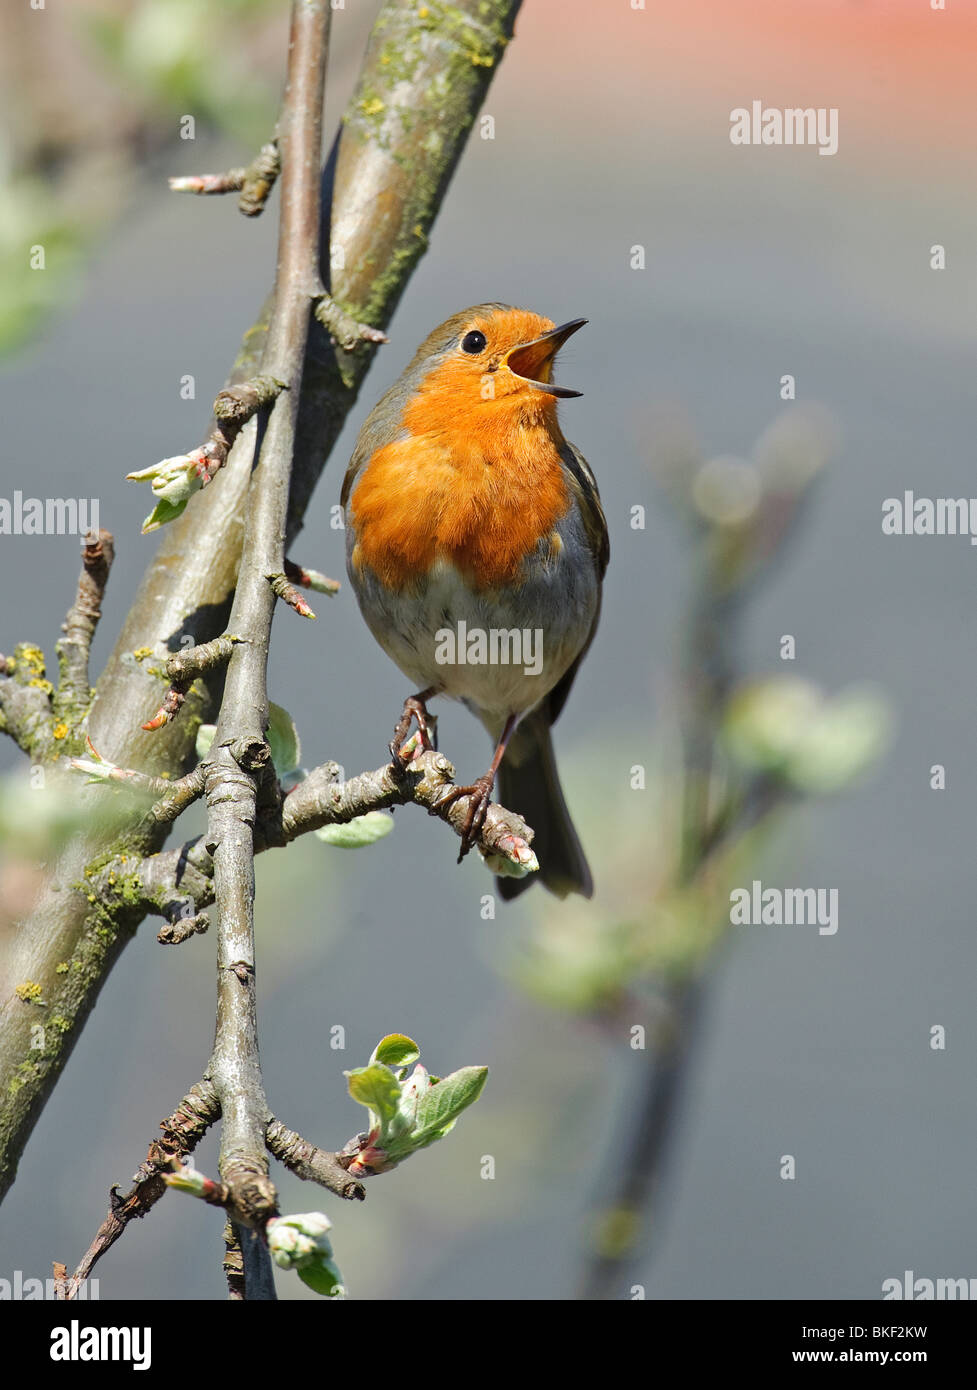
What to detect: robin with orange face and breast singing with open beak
<box><xmin>340</xmin><ymin>303</ymin><xmax>610</xmax><ymax>899</ymax></box>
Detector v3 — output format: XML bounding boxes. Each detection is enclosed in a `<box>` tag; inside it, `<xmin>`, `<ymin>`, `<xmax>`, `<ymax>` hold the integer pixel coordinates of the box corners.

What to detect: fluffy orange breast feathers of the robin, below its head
<box><xmin>350</xmin><ymin>392</ymin><xmax>570</xmax><ymax>589</ymax></box>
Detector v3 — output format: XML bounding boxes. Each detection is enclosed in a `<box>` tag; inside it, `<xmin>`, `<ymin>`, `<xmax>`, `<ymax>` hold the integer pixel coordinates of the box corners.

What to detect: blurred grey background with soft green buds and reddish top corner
<box><xmin>0</xmin><ymin>0</ymin><xmax>977</xmax><ymax>1300</ymax></box>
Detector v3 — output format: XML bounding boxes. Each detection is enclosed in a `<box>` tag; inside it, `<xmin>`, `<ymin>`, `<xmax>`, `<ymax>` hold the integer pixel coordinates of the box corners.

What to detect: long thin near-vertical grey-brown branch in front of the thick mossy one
<box><xmin>206</xmin><ymin>0</ymin><xmax>331</xmax><ymax>1300</ymax></box>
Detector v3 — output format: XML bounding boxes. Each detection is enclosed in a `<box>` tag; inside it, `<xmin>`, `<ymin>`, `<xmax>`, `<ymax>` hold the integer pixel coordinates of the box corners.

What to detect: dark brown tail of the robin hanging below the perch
<box><xmin>496</xmin><ymin>716</ymin><xmax>593</xmax><ymax>899</ymax></box>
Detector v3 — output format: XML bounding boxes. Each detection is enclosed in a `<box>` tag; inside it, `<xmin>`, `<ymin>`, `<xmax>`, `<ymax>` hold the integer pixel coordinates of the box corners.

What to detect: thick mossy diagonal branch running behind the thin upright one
<box><xmin>0</xmin><ymin>0</ymin><xmax>518</xmax><ymax>1197</ymax></box>
